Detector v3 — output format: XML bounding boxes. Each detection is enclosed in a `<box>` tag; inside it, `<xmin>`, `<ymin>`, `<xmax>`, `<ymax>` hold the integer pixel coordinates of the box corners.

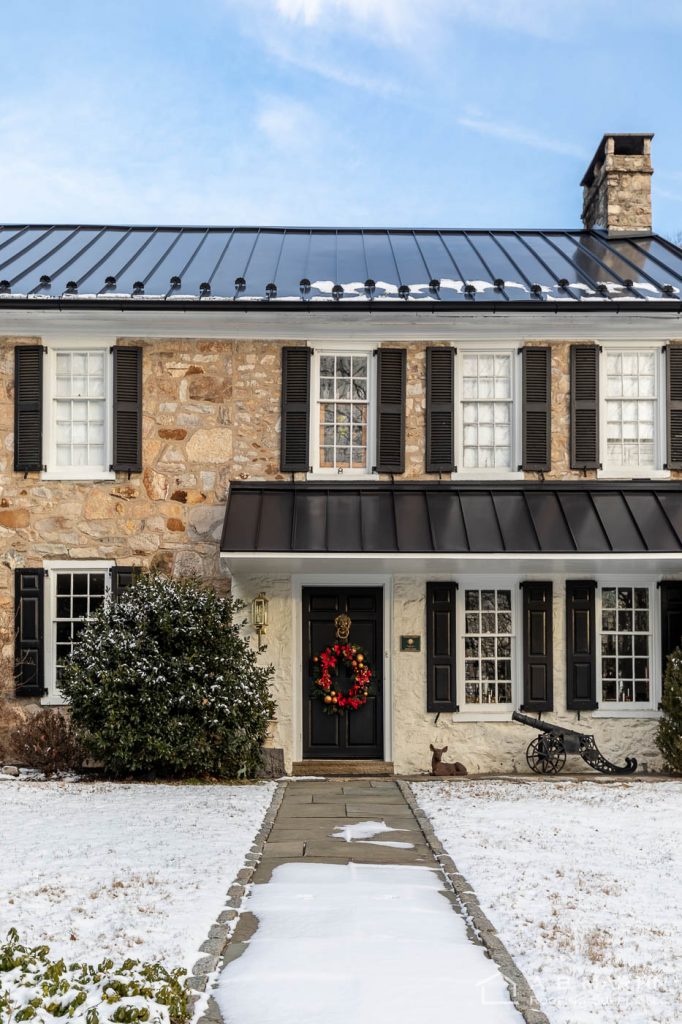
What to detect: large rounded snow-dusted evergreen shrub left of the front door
<box><xmin>59</xmin><ymin>573</ymin><xmax>274</xmax><ymax>778</ymax></box>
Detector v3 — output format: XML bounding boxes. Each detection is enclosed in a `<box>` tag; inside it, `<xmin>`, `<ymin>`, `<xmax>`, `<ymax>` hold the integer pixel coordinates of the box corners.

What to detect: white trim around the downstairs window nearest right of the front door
<box><xmin>455</xmin><ymin>574</ymin><xmax>525</xmax><ymax>722</ymax></box>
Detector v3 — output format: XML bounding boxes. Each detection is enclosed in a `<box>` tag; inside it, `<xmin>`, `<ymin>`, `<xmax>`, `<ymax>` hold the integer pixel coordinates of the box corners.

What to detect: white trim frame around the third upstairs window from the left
<box><xmin>451</xmin><ymin>342</ymin><xmax>525</xmax><ymax>480</ymax></box>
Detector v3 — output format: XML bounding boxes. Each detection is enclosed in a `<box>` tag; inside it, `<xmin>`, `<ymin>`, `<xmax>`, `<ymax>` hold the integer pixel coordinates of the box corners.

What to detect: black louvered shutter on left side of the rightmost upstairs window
<box><xmin>570</xmin><ymin>345</ymin><xmax>599</xmax><ymax>469</ymax></box>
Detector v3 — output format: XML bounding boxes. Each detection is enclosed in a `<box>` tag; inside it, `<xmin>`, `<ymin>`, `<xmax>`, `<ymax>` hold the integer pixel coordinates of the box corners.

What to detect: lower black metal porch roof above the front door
<box><xmin>220</xmin><ymin>480</ymin><xmax>682</xmax><ymax>554</ymax></box>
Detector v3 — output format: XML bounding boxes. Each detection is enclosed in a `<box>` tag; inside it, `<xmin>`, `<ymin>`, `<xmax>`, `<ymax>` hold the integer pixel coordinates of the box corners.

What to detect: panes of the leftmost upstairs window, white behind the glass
<box><xmin>53</xmin><ymin>349</ymin><xmax>106</xmax><ymax>470</ymax></box>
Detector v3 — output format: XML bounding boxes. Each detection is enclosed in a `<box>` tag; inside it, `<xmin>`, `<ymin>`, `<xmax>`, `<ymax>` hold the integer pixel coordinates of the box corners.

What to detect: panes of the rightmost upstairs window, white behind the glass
<box><xmin>606</xmin><ymin>350</ymin><xmax>657</xmax><ymax>469</ymax></box>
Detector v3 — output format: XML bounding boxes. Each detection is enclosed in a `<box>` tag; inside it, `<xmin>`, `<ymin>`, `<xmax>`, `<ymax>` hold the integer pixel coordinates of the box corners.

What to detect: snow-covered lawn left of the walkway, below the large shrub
<box><xmin>0</xmin><ymin>779</ymin><xmax>274</xmax><ymax>971</ymax></box>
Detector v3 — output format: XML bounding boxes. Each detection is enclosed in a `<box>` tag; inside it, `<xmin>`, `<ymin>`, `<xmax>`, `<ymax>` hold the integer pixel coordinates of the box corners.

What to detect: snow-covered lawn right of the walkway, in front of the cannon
<box><xmin>413</xmin><ymin>779</ymin><xmax>682</xmax><ymax>1024</ymax></box>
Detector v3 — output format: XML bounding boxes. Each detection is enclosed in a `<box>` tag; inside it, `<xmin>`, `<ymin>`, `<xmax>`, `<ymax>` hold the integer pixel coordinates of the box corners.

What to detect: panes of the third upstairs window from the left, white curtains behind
<box><xmin>461</xmin><ymin>352</ymin><xmax>513</xmax><ymax>469</ymax></box>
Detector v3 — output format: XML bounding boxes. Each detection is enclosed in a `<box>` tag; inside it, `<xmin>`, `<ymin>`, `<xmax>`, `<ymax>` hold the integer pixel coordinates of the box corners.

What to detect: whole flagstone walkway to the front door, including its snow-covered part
<box><xmin>205</xmin><ymin>778</ymin><xmax>545</xmax><ymax>1024</ymax></box>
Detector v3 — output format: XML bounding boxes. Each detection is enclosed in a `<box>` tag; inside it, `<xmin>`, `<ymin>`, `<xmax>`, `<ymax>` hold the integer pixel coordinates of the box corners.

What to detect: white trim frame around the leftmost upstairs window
<box><xmin>40</xmin><ymin>340</ymin><xmax>116</xmax><ymax>480</ymax></box>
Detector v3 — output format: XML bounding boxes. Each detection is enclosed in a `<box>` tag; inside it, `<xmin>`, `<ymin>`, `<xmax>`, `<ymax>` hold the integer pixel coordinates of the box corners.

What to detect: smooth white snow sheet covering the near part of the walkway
<box><xmin>214</xmin><ymin>863</ymin><xmax>523</xmax><ymax>1024</ymax></box>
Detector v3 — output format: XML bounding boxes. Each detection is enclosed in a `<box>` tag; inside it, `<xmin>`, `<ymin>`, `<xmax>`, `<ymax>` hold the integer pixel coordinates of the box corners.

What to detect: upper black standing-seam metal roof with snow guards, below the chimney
<box><xmin>0</xmin><ymin>224</ymin><xmax>682</xmax><ymax>308</ymax></box>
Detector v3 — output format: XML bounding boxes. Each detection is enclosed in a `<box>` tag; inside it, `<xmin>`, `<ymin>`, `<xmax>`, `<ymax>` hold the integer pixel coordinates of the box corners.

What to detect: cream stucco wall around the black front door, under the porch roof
<box><xmin>232</xmin><ymin>575</ymin><xmax>662</xmax><ymax>774</ymax></box>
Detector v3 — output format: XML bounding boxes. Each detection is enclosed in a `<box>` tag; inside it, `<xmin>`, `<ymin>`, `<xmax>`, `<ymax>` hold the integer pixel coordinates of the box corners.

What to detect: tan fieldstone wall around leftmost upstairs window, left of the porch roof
<box><xmin>0</xmin><ymin>337</ymin><xmax>292</xmax><ymax>693</ymax></box>
